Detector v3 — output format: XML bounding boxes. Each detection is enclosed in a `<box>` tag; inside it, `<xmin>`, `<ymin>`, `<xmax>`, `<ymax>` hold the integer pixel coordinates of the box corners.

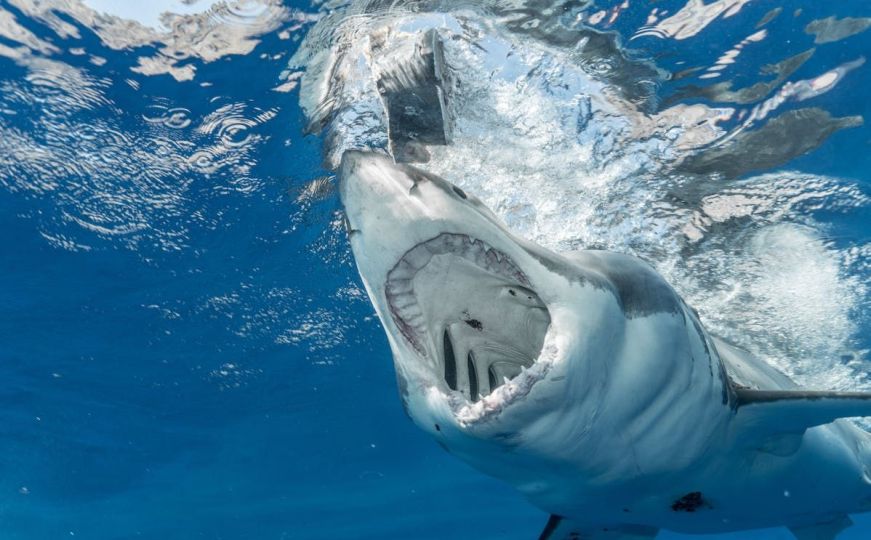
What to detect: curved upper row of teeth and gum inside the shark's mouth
<box><xmin>384</xmin><ymin>233</ymin><xmax>529</xmax><ymax>356</ymax></box>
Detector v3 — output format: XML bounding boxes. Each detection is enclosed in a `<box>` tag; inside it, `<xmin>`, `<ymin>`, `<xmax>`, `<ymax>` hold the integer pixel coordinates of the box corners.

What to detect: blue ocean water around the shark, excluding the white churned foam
<box><xmin>0</xmin><ymin>0</ymin><xmax>871</xmax><ymax>539</ymax></box>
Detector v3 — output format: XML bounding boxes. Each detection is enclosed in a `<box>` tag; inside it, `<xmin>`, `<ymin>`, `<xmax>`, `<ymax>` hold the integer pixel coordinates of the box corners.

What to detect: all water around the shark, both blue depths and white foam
<box><xmin>0</xmin><ymin>0</ymin><xmax>871</xmax><ymax>539</ymax></box>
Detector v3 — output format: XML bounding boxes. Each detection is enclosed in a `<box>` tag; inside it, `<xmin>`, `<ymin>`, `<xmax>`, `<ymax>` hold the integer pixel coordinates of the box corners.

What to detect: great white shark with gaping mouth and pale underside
<box><xmin>339</xmin><ymin>151</ymin><xmax>871</xmax><ymax>540</ymax></box>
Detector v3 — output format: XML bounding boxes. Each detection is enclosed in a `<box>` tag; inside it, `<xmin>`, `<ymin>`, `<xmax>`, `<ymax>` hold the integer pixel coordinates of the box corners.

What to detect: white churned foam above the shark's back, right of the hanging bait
<box><xmin>294</xmin><ymin>7</ymin><xmax>871</xmax><ymax>392</ymax></box>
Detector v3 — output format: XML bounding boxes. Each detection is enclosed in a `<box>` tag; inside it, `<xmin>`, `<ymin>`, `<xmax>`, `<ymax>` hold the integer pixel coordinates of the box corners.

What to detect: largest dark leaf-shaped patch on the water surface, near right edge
<box><xmin>679</xmin><ymin>107</ymin><xmax>863</xmax><ymax>178</ymax></box>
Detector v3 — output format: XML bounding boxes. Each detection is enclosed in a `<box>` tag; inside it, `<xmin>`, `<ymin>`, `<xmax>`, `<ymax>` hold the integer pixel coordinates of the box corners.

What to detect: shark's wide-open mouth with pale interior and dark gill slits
<box><xmin>385</xmin><ymin>233</ymin><xmax>550</xmax><ymax>405</ymax></box>
